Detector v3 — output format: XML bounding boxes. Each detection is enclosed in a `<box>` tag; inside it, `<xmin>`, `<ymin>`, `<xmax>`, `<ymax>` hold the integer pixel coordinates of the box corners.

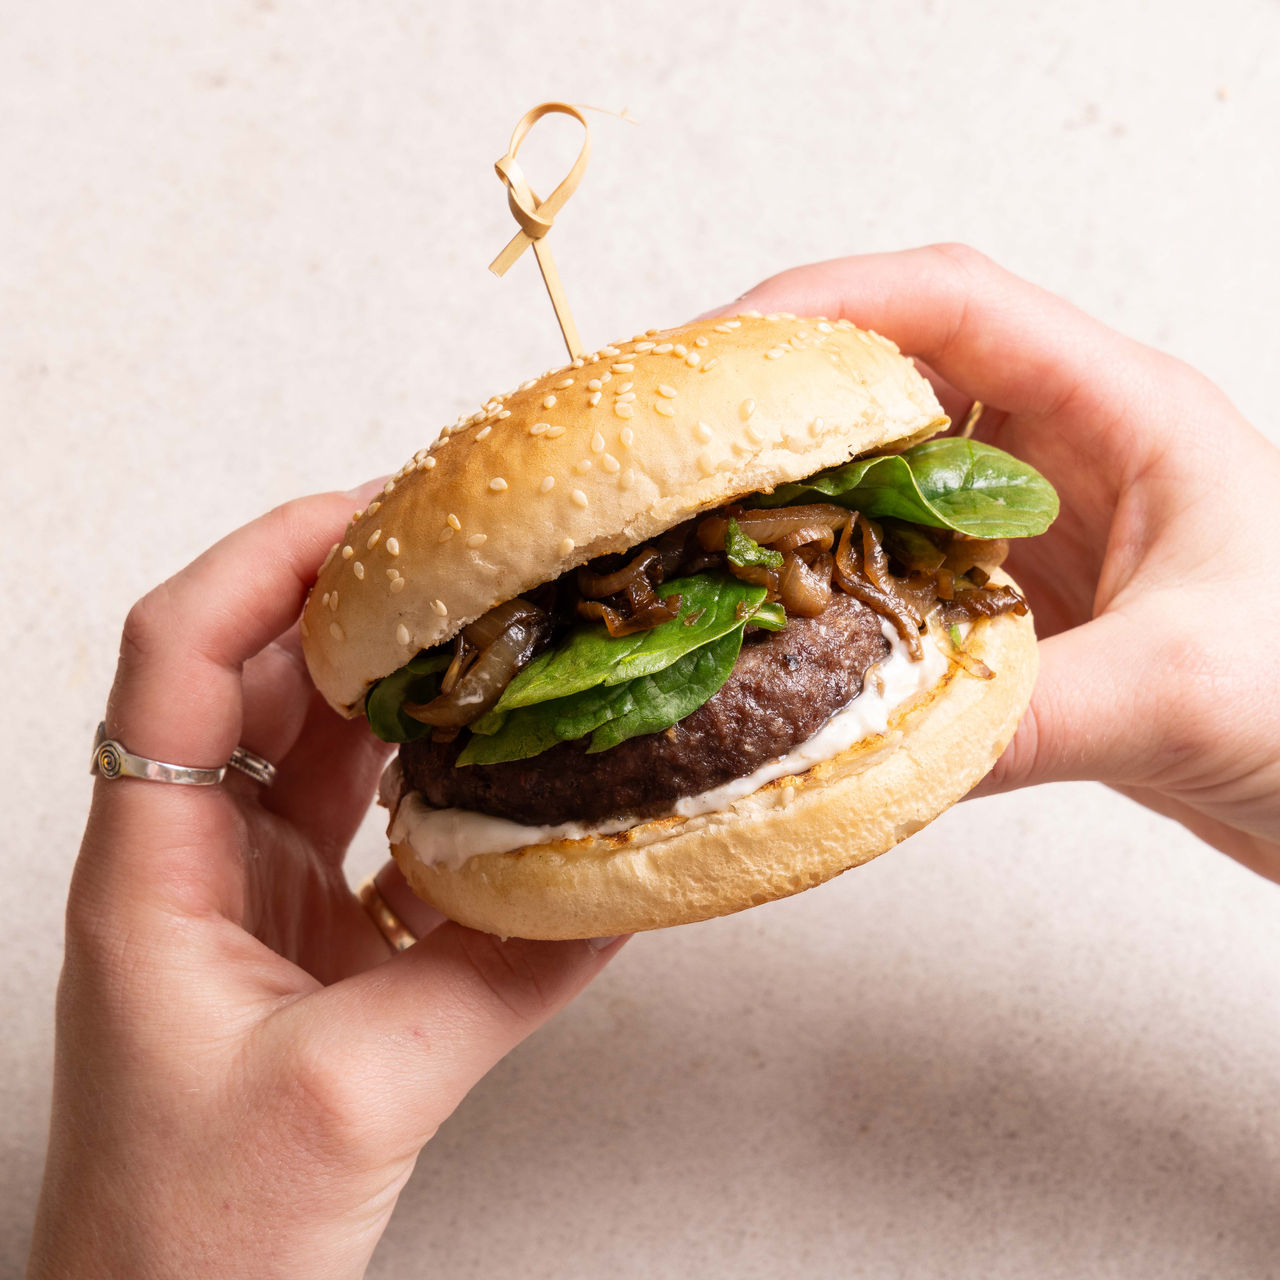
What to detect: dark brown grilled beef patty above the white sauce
<box><xmin>401</xmin><ymin>591</ymin><xmax>890</xmax><ymax>826</ymax></box>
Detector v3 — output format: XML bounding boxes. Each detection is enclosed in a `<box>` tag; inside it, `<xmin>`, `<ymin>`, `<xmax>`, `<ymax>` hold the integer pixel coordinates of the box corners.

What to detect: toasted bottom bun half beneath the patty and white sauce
<box><xmin>392</xmin><ymin>599</ymin><xmax>1037</xmax><ymax>938</ymax></box>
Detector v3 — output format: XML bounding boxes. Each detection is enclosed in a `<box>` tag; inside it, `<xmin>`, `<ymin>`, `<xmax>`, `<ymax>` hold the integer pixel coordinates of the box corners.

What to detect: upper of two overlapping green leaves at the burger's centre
<box><xmin>486</xmin><ymin>573</ymin><xmax>765</xmax><ymax>716</ymax></box>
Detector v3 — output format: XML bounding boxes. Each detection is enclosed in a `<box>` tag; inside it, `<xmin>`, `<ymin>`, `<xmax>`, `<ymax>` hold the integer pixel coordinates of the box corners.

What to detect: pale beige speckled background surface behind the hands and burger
<box><xmin>0</xmin><ymin>0</ymin><xmax>1280</xmax><ymax>1280</ymax></box>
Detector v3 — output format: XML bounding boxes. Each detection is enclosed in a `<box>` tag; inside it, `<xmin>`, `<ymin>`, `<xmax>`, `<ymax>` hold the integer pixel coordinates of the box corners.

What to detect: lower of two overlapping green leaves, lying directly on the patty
<box><xmin>457</xmin><ymin>622</ymin><xmax>744</xmax><ymax>765</ymax></box>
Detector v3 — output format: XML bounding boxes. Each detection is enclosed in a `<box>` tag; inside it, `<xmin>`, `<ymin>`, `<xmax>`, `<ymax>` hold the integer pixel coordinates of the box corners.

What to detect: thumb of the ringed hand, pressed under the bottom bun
<box><xmin>290</xmin><ymin>923</ymin><xmax>622</xmax><ymax>1153</ymax></box>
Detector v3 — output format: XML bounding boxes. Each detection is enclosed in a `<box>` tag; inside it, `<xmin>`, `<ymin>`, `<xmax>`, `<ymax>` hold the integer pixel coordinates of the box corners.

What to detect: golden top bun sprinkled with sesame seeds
<box><xmin>302</xmin><ymin>312</ymin><xmax>947</xmax><ymax>716</ymax></box>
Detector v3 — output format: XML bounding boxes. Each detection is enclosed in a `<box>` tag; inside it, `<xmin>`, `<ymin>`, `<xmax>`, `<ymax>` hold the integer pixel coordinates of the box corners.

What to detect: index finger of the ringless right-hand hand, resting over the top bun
<box><xmin>730</xmin><ymin>244</ymin><xmax>1149</xmax><ymax>430</ymax></box>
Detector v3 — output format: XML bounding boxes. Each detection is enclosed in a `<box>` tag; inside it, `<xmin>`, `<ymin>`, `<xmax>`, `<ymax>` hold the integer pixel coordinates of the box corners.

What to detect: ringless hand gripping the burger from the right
<box><xmin>732</xmin><ymin>246</ymin><xmax>1280</xmax><ymax>881</ymax></box>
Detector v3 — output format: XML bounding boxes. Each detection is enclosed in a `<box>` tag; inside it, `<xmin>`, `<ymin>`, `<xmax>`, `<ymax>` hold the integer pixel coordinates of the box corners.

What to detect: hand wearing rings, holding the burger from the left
<box><xmin>28</xmin><ymin>494</ymin><xmax>618</xmax><ymax>1280</ymax></box>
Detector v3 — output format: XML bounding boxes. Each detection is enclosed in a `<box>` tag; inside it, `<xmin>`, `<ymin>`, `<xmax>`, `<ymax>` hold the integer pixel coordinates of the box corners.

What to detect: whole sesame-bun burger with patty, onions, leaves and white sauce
<box><xmin>301</xmin><ymin>314</ymin><xmax>1057</xmax><ymax>938</ymax></box>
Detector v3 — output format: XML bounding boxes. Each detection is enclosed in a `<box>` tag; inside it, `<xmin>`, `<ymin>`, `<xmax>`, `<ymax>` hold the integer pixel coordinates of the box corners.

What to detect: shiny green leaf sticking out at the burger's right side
<box><xmin>759</xmin><ymin>436</ymin><xmax>1057</xmax><ymax>538</ymax></box>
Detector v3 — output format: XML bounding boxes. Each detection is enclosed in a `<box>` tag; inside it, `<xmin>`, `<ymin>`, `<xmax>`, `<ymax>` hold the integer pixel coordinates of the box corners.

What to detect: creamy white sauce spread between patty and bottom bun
<box><xmin>389</xmin><ymin>622</ymin><xmax>947</xmax><ymax>869</ymax></box>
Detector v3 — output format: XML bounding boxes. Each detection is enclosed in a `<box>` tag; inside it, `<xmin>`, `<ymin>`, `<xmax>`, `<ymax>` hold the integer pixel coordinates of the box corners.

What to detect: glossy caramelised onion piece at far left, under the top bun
<box><xmin>403</xmin><ymin>599</ymin><xmax>552</xmax><ymax>730</ymax></box>
